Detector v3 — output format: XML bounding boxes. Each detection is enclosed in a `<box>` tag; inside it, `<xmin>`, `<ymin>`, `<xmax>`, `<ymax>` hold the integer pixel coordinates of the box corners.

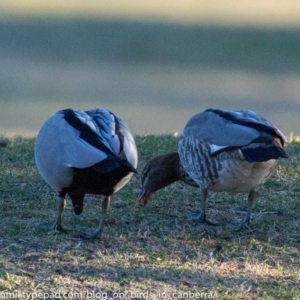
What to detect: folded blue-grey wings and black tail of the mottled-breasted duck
<box><xmin>183</xmin><ymin>109</ymin><xmax>287</xmax><ymax>162</ymax></box>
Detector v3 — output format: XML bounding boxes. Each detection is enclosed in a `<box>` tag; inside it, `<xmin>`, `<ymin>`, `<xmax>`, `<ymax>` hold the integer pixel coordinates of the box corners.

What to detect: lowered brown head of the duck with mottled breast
<box><xmin>139</xmin><ymin>152</ymin><xmax>181</xmax><ymax>205</ymax></box>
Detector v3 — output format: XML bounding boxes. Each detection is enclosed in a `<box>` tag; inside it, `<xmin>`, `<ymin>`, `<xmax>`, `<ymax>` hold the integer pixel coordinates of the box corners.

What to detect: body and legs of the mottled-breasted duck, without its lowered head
<box><xmin>178</xmin><ymin>109</ymin><xmax>288</xmax><ymax>230</ymax></box>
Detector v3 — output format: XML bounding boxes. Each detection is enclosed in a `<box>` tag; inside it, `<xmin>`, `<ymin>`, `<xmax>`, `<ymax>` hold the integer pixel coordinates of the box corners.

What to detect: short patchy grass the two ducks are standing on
<box><xmin>0</xmin><ymin>135</ymin><xmax>300</xmax><ymax>299</ymax></box>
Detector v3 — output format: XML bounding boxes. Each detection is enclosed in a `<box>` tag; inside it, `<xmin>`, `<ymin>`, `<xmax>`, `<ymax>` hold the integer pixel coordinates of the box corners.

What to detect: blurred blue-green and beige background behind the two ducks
<box><xmin>0</xmin><ymin>0</ymin><xmax>300</xmax><ymax>136</ymax></box>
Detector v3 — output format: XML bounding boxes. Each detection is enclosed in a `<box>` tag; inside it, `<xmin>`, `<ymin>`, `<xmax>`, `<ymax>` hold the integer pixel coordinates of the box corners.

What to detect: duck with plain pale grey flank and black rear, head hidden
<box><xmin>34</xmin><ymin>108</ymin><xmax>138</xmax><ymax>239</ymax></box>
